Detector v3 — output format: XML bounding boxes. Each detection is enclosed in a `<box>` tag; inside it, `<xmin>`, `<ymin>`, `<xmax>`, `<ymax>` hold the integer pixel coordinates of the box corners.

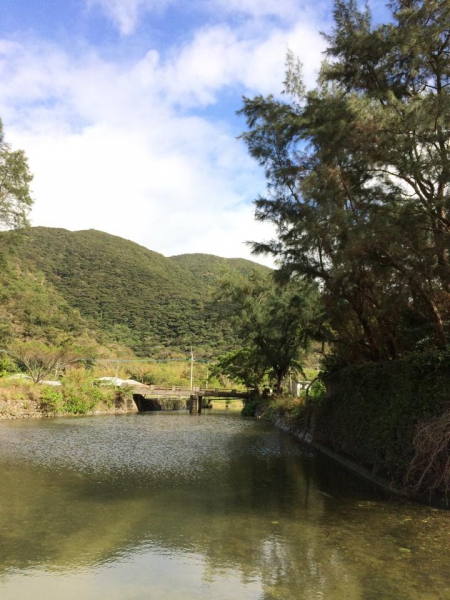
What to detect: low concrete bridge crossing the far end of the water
<box><xmin>131</xmin><ymin>384</ymin><xmax>256</xmax><ymax>414</ymax></box>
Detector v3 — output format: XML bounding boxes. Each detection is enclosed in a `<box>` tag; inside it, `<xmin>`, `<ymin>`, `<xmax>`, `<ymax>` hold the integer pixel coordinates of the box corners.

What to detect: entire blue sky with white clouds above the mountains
<box><xmin>0</xmin><ymin>0</ymin><xmax>384</xmax><ymax>257</ymax></box>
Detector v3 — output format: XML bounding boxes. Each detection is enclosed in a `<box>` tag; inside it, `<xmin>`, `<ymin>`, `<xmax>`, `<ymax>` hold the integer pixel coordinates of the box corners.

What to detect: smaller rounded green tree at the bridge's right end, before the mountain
<box><xmin>216</xmin><ymin>273</ymin><xmax>322</xmax><ymax>394</ymax></box>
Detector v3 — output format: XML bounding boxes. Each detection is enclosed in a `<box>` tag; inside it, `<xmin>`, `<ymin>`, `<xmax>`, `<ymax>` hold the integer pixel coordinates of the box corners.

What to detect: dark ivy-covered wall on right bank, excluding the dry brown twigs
<box><xmin>308</xmin><ymin>352</ymin><xmax>450</xmax><ymax>482</ymax></box>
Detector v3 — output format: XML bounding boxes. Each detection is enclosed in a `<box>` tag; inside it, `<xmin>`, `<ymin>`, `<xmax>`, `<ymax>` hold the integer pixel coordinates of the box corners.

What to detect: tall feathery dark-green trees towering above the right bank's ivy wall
<box><xmin>242</xmin><ymin>0</ymin><xmax>450</xmax><ymax>367</ymax></box>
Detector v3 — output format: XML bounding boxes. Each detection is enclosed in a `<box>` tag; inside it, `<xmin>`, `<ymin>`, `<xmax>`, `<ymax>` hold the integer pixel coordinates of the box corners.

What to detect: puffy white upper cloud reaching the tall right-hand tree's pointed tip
<box><xmin>135</xmin><ymin>23</ymin><xmax>325</xmax><ymax>107</ymax></box>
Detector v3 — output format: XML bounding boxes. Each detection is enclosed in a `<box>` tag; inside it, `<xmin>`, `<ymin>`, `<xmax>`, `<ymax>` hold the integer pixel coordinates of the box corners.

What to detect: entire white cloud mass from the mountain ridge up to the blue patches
<box><xmin>0</xmin><ymin>8</ymin><xmax>323</xmax><ymax>261</ymax></box>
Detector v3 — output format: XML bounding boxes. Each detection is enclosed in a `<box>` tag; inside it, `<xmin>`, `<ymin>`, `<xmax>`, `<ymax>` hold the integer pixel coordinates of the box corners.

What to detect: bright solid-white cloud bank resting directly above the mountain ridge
<box><xmin>14</xmin><ymin>118</ymin><xmax>272</xmax><ymax>262</ymax></box>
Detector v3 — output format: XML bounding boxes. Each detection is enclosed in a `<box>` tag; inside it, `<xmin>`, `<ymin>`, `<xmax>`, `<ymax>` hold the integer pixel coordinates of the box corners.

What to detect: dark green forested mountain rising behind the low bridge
<box><xmin>7</xmin><ymin>227</ymin><xmax>266</xmax><ymax>357</ymax></box>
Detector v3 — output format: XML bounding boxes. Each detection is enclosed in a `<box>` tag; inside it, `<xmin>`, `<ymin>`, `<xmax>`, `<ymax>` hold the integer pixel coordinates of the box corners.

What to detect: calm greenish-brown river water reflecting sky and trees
<box><xmin>0</xmin><ymin>412</ymin><xmax>450</xmax><ymax>600</ymax></box>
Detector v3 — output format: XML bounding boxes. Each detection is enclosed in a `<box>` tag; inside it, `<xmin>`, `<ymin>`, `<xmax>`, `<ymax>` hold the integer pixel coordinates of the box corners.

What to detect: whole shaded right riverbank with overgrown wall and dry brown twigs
<box><xmin>253</xmin><ymin>353</ymin><xmax>450</xmax><ymax>507</ymax></box>
